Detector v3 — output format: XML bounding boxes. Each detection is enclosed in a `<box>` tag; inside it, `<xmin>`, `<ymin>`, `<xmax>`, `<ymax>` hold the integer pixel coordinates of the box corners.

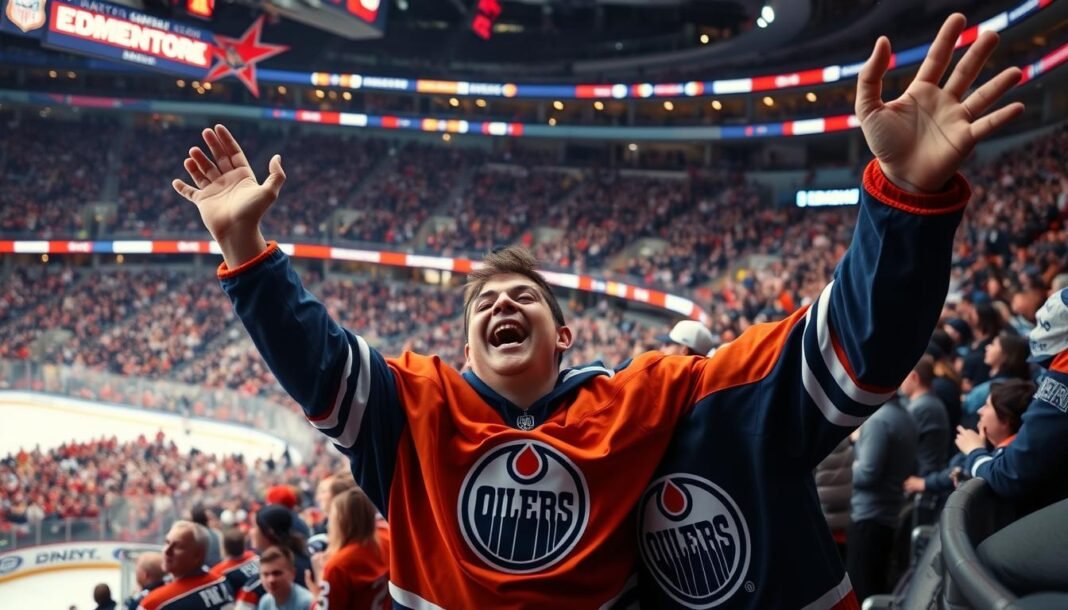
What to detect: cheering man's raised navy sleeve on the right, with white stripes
<box><xmin>796</xmin><ymin>161</ymin><xmax>970</xmax><ymax>465</ymax></box>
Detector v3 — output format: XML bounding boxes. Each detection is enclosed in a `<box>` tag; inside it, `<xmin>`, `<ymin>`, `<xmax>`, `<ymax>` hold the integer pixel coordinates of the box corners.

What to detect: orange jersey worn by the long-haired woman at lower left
<box><xmin>316</xmin><ymin>522</ymin><xmax>391</xmax><ymax>610</ymax></box>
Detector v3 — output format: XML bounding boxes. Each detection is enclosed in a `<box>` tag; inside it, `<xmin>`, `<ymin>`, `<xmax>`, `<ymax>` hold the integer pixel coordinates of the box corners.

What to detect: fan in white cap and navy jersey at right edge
<box><xmin>957</xmin><ymin>288</ymin><xmax>1068</xmax><ymax>512</ymax></box>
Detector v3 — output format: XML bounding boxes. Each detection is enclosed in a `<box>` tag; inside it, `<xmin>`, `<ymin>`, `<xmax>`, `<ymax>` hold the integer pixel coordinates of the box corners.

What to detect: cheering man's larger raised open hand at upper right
<box><xmin>857</xmin><ymin>13</ymin><xmax>1023</xmax><ymax>192</ymax></box>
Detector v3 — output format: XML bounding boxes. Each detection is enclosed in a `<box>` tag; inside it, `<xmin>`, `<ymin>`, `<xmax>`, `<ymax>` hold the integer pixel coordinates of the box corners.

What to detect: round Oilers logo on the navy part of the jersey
<box><xmin>638</xmin><ymin>474</ymin><xmax>751</xmax><ymax>608</ymax></box>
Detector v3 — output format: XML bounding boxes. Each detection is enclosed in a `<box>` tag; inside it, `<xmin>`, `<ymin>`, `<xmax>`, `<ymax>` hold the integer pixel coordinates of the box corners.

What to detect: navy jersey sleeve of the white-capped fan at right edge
<box><xmin>965</xmin><ymin>361</ymin><xmax>1068</xmax><ymax>499</ymax></box>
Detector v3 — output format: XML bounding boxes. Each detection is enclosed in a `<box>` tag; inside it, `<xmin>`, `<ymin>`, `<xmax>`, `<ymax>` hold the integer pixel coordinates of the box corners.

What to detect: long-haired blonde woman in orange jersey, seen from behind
<box><xmin>312</xmin><ymin>487</ymin><xmax>391</xmax><ymax>610</ymax></box>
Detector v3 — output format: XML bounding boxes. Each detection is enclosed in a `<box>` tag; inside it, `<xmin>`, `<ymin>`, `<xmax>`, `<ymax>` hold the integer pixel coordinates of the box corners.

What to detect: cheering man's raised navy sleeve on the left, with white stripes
<box><xmin>220</xmin><ymin>244</ymin><xmax>406</xmax><ymax>515</ymax></box>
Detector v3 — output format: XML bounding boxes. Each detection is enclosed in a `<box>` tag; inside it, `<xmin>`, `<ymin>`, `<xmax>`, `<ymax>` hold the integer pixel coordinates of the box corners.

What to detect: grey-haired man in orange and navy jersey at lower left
<box><xmin>138</xmin><ymin>521</ymin><xmax>234</xmax><ymax>610</ymax></box>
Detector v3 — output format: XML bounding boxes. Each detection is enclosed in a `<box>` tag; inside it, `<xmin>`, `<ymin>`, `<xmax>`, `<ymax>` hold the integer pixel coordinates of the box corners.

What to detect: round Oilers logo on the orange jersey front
<box><xmin>458</xmin><ymin>440</ymin><xmax>590</xmax><ymax>574</ymax></box>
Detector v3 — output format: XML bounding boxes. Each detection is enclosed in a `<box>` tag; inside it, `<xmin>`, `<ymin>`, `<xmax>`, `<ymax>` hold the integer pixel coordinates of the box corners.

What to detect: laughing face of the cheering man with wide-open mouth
<box><xmin>465</xmin><ymin>273</ymin><xmax>571</xmax><ymax>381</ymax></box>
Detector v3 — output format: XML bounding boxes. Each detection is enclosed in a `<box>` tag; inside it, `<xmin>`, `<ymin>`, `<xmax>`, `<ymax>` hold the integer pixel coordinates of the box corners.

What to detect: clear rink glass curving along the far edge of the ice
<box><xmin>0</xmin><ymin>360</ymin><xmax>315</xmax><ymax>455</ymax></box>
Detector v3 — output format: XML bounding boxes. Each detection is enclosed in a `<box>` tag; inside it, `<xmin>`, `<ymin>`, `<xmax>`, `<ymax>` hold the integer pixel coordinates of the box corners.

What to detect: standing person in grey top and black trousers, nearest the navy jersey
<box><xmin>846</xmin><ymin>397</ymin><xmax>920</xmax><ymax>604</ymax></box>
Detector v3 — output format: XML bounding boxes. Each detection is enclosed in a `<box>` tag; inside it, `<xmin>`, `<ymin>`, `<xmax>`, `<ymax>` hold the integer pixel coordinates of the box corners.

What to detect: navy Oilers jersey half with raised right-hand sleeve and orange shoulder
<box><xmin>638</xmin><ymin>165</ymin><xmax>969</xmax><ymax>610</ymax></box>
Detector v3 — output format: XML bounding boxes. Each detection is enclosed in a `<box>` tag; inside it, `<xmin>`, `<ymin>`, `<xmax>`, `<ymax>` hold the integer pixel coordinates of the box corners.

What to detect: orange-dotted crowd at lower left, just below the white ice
<box><xmin>0</xmin><ymin>432</ymin><xmax>343</xmax><ymax>539</ymax></box>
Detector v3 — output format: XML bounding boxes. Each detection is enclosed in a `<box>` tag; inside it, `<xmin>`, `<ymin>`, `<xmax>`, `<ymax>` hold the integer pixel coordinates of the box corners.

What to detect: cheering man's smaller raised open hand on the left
<box><xmin>171</xmin><ymin>125</ymin><xmax>285</xmax><ymax>268</ymax></box>
